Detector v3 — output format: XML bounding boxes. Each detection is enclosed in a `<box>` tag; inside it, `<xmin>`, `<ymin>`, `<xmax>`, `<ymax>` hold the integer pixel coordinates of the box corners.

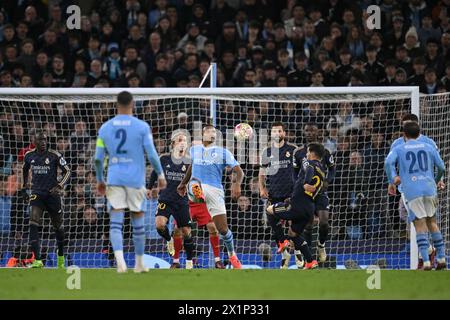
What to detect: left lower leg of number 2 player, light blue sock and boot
<box><xmin>109</xmin><ymin>209</ymin><xmax>127</xmax><ymax>273</ymax></box>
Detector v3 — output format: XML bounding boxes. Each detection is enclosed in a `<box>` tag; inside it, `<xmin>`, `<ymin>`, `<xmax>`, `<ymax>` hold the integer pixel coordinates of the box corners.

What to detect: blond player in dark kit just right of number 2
<box><xmin>149</xmin><ymin>130</ymin><xmax>194</xmax><ymax>269</ymax></box>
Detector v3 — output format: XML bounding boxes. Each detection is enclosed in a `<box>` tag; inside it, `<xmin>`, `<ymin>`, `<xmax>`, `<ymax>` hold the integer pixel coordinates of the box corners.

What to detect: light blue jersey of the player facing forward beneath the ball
<box><xmin>189</xmin><ymin>145</ymin><xmax>239</xmax><ymax>189</ymax></box>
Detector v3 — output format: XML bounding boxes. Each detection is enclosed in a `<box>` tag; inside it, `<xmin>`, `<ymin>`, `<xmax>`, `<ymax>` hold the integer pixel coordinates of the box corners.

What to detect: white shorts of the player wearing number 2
<box><xmin>106</xmin><ymin>186</ymin><xmax>147</xmax><ymax>212</ymax></box>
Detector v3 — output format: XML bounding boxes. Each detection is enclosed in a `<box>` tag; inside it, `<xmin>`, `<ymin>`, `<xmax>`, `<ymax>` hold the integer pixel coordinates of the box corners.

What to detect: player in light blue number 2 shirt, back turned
<box><xmin>95</xmin><ymin>91</ymin><xmax>167</xmax><ymax>273</ymax></box>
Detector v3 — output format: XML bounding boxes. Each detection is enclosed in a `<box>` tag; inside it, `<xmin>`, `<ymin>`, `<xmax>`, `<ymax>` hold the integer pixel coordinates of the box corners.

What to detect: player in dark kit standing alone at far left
<box><xmin>21</xmin><ymin>131</ymin><xmax>70</xmax><ymax>268</ymax></box>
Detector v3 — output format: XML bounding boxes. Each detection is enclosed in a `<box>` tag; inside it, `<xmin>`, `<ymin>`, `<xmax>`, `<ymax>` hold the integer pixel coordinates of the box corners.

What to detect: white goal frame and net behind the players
<box><xmin>0</xmin><ymin>87</ymin><xmax>450</xmax><ymax>269</ymax></box>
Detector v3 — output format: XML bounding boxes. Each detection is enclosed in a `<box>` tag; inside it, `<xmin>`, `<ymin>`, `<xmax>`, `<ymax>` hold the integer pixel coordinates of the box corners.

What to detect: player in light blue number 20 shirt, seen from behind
<box><xmin>385</xmin><ymin>121</ymin><xmax>447</xmax><ymax>270</ymax></box>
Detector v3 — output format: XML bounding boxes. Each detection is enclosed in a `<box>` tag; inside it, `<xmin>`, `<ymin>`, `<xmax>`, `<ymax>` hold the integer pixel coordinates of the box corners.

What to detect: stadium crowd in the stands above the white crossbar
<box><xmin>0</xmin><ymin>0</ymin><xmax>450</xmax><ymax>93</ymax></box>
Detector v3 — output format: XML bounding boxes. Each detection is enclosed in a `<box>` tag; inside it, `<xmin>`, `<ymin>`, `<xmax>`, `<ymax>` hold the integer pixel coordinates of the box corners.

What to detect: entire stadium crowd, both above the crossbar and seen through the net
<box><xmin>0</xmin><ymin>0</ymin><xmax>450</xmax><ymax>255</ymax></box>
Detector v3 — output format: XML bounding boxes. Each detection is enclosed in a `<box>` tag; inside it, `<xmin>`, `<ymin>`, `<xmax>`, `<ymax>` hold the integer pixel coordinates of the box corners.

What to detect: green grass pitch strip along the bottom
<box><xmin>0</xmin><ymin>269</ymin><xmax>450</xmax><ymax>300</ymax></box>
